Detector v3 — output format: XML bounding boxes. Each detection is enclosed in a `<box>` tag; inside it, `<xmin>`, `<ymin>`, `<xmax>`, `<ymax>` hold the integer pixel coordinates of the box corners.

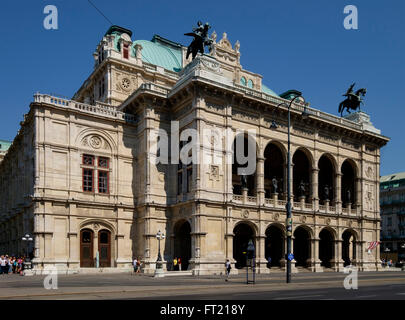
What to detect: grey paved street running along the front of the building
<box><xmin>0</xmin><ymin>272</ymin><xmax>405</xmax><ymax>300</ymax></box>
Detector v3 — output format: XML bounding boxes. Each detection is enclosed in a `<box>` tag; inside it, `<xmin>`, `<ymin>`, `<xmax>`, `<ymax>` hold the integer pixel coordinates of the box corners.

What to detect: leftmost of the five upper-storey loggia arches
<box><xmin>232</xmin><ymin>134</ymin><xmax>257</xmax><ymax>196</ymax></box>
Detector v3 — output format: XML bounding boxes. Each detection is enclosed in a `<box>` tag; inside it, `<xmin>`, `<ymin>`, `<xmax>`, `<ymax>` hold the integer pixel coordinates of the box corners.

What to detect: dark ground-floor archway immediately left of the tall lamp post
<box><xmin>264</xmin><ymin>225</ymin><xmax>284</xmax><ymax>268</ymax></box>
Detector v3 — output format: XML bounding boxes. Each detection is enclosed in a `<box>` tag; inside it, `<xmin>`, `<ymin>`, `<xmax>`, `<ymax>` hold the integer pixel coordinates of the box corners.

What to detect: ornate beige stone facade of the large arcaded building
<box><xmin>0</xmin><ymin>25</ymin><xmax>388</xmax><ymax>275</ymax></box>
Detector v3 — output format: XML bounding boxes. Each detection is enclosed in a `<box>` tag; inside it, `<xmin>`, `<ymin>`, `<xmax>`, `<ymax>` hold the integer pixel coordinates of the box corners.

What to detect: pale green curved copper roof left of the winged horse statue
<box><xmin>132</xmin><ymin>37</ymin><xmax>182</xmax><ymax>72</ymax></box>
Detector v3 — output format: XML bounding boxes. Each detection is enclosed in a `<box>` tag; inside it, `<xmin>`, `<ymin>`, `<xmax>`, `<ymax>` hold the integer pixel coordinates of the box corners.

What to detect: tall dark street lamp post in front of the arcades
<box><xmin>270</xmin><ymin>92</ymin><xmax>308</xmax><ymax>283</ymax></box>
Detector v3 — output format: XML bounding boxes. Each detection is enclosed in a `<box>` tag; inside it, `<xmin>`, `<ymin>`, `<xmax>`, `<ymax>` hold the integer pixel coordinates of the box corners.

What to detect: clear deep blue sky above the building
<box><xmin>0</xmin><ymin>0</ymin><xmax>405</xmax><ymax>175</ymax></box>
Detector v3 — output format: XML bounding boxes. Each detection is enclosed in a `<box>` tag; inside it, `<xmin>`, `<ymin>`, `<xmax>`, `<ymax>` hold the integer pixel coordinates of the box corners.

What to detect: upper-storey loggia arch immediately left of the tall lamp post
<box><xmin>264</xmin><ymin>143</ymin><xmax>286</xmax><ymax>198</ymax></box>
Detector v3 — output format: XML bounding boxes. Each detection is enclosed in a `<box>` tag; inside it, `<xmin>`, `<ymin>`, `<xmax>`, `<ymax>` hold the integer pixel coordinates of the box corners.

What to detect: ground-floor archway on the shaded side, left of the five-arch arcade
<box><xmin>174</xmin><ymin>220</ymin><xmax>191</xmax><ymax>270</ymax></box>
